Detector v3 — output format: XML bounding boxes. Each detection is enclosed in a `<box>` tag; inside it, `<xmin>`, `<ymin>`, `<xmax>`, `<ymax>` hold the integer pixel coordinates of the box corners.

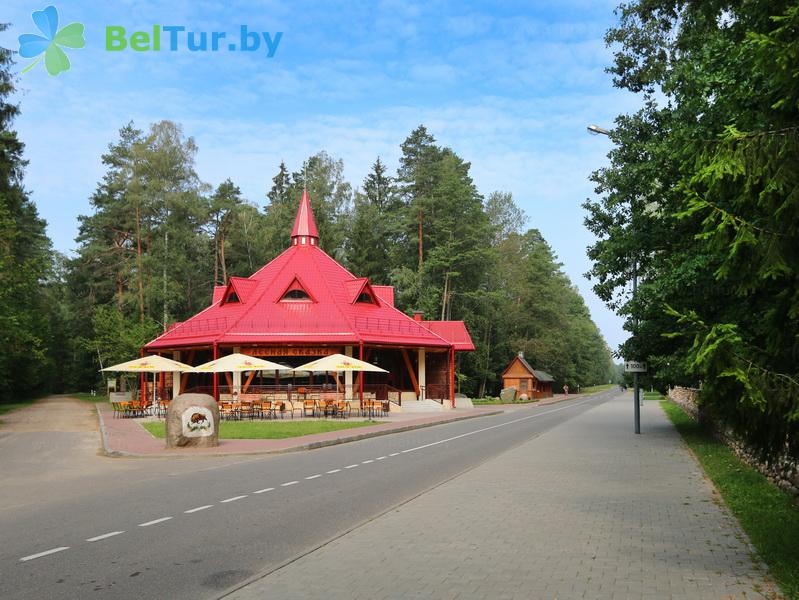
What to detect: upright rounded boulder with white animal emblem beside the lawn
<box><xmin>166</xmin><ymin>394</ymin><xmax>219</xmax><ymax>448</ymax></box>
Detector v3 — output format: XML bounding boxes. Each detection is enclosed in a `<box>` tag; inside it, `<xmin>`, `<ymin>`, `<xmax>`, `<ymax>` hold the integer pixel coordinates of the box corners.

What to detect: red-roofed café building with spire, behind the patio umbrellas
<box><xmin>145</xmin><ymin>192</ymin><xmax>474</xmax><ymax>403</ymax></box>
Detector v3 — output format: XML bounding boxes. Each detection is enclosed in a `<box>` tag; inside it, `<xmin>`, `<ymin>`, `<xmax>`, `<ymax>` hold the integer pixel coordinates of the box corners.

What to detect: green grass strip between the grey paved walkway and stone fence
<box><xmin>660</xmin><ymin>402</ymin><xmax>799</xmax><ymax>600</ymax></box>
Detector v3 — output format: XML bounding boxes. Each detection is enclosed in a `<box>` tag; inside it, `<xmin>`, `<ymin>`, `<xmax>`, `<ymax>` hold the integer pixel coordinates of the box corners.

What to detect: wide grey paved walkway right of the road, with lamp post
<box><xmin>230</xmin><ymin>394</ymin><xmax>778</xmax><ymax>600</ymax></box>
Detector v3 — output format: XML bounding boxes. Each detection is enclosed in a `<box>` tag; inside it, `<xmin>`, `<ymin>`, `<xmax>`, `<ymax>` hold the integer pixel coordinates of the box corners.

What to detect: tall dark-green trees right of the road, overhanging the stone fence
<box><xmin>586</xmin><ymin>0</ymin><xmax>799</xmax><ymax>460</ymax></box>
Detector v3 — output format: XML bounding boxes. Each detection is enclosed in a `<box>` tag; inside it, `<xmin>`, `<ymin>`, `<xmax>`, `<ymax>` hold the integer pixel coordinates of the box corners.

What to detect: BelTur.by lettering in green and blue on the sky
<box><xmin>105</xmin><ymin>25</ymin><xmax>283</xmax><ymax>58</ymax></box>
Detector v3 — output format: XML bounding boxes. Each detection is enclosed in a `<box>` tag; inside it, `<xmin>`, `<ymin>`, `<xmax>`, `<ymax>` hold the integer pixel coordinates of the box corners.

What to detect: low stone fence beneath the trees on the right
<box><xmin>668</xmin><ymin>387</ymin><xmax>799</xmax><ymax>499</ymax></box>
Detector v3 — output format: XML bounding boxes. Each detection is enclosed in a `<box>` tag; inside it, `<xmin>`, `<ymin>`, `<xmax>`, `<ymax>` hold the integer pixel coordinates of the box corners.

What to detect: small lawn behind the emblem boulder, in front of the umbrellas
<box><xmin>141</xmin><ymin>421</ymin><xmax>380</xmax><ymax>440</ymax></box>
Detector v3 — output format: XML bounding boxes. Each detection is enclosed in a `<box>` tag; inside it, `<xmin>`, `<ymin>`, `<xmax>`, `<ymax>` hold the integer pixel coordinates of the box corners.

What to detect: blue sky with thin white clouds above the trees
<box><xmin>0</xmin><ymin>0</ymin><xmax>636</xmax><ymax>349</ymax></box>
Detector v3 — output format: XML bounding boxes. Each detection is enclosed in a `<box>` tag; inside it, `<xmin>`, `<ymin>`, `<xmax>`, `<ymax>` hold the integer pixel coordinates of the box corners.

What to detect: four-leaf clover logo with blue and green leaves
<box><xmin>19</xmin><ymin>6</ymin><xmax>86</xmax><ymax>75</ymax></box>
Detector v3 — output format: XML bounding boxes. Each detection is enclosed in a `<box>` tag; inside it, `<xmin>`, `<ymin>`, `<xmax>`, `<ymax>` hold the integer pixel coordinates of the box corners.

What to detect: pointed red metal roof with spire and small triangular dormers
<box><xmin>145</xmin><ymin>193</ymin><xmax>474</xmax><ymax>350</ymax></box>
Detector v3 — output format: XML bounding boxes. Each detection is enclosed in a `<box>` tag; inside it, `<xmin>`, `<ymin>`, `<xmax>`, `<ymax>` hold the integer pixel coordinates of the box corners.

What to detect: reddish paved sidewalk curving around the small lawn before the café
<box><xmin>97</xmin><ymin>403</ymin><xmax>502</xmax><ymax>457</ymax></box>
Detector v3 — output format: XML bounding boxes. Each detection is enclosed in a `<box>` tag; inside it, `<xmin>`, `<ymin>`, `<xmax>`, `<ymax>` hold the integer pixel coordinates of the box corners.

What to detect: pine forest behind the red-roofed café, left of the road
<box><xmin>0</xmin><ymin>44</ymin><xmax>615</xmax><ymax>400</ymax></box>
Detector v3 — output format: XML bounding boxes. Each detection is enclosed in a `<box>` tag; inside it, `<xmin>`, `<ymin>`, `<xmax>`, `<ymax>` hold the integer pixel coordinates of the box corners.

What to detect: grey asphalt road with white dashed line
<box><xmin>0</xmin><ymin>391</ymin><xmax>616</xmax><ymax>600</ymax></box>
